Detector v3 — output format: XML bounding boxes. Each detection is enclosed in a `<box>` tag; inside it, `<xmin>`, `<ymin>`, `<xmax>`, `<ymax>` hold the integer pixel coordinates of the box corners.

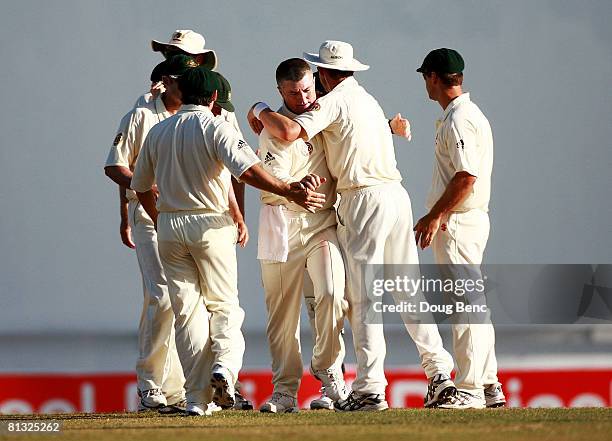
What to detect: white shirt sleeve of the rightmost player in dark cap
<box><xmin>447</xmin><ymin>118</ymin><xmax>482</xmax><ymax>177</ymax></box>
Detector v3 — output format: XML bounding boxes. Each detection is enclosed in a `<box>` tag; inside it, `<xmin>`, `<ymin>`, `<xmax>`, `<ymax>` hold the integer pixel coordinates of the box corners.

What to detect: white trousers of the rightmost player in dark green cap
<box><xmin>432</xmin><ymin>210</ymin><xmax>497</xmax><ymax>398</ymax></box>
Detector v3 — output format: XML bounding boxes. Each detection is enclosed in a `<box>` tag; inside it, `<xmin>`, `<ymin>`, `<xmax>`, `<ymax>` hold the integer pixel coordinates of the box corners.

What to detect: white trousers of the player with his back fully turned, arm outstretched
<box><xmin>157</xmin><ymin>211</ymin><xmax>244</xmax><ymax>404</ymax></box>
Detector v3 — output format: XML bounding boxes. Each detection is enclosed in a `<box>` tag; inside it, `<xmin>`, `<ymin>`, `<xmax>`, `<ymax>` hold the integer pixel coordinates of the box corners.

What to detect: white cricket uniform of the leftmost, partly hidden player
<box><xmin>106</xmin><ymin>96</ymin><xmax>185</xmax><ymax>403</ymax></box>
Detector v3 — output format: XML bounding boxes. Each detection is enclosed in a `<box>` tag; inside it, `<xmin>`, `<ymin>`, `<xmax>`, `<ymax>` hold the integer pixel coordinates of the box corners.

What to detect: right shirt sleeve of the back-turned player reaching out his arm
<box><xmin>214</xmin><ymin>122</ymin><xmax>261</xmax><ymax>179</ymax></box>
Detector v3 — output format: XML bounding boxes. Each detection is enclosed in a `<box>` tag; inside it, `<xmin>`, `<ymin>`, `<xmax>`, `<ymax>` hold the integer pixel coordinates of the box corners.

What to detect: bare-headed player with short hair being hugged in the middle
<box><xmin>258</xmin><ymin>58</ymin><xmax>348</xmax><ymax>413</ymax></box>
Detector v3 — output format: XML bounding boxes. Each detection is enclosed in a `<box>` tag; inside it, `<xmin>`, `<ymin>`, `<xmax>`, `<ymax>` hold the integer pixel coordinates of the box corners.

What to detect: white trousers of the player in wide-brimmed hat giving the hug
<box><xmin>338</xmin><ymin>183</ymin><xmax>453</xmax><ymax>394</ymax></box>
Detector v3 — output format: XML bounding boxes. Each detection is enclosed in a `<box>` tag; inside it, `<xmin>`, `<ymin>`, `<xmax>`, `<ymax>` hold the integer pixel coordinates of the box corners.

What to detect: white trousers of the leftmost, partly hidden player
<box><xmin>128</xmin><ymin>200</ymin><xmax>185</xmax><ymax>403</ymax></box>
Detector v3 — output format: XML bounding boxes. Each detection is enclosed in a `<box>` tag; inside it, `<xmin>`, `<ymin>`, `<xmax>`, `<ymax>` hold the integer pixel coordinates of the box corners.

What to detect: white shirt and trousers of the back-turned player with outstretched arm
<box><xmin>132</xmin><ymin>105</ymin><xmax>259</xmax><ymax>405</ymax></box>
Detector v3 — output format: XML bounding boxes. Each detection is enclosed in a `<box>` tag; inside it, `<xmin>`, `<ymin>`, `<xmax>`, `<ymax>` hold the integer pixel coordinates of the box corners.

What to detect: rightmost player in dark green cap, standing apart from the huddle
<box><xmin>414</xmin><ymin>48</ymin><xmax>506</xmax><ymax>407</ymax></box>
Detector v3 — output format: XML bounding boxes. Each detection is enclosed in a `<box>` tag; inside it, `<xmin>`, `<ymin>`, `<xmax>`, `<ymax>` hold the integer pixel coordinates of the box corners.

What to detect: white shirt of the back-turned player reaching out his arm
<box><xmin>132</xmin><ymin>105</ymin><xmax>260</xmax><ymax>213</ymax></box>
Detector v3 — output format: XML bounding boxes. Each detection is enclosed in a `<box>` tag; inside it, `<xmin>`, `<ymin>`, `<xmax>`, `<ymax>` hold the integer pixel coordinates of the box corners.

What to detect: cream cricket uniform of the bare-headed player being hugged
<box><xmin>259</xmin><ymin>106</ymin><xmax>347</xmax><ymax>397</ymax></box>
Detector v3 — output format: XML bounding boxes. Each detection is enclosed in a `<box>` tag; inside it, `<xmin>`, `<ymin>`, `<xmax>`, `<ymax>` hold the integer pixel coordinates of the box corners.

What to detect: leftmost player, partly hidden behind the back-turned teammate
<box><xmin>104</xmin><ymin>56</ymin><xmax>195</xmax><ymax>413</ymax></box>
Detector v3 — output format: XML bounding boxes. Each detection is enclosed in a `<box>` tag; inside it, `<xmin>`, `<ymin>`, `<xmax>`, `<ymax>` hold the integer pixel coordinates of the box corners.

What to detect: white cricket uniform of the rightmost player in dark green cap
<box><xmin>427</xmin><ymin>93</ymin><xmax>497</xmax><ymax>398</ymax></box>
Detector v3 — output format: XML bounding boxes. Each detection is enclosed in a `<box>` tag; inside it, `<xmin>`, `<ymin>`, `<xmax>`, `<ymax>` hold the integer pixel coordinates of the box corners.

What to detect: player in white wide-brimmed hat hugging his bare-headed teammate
<box><xmin>250</xmin><ymin>41</ymin><xmax>468</xmax><ymax>411</ymax></box>
